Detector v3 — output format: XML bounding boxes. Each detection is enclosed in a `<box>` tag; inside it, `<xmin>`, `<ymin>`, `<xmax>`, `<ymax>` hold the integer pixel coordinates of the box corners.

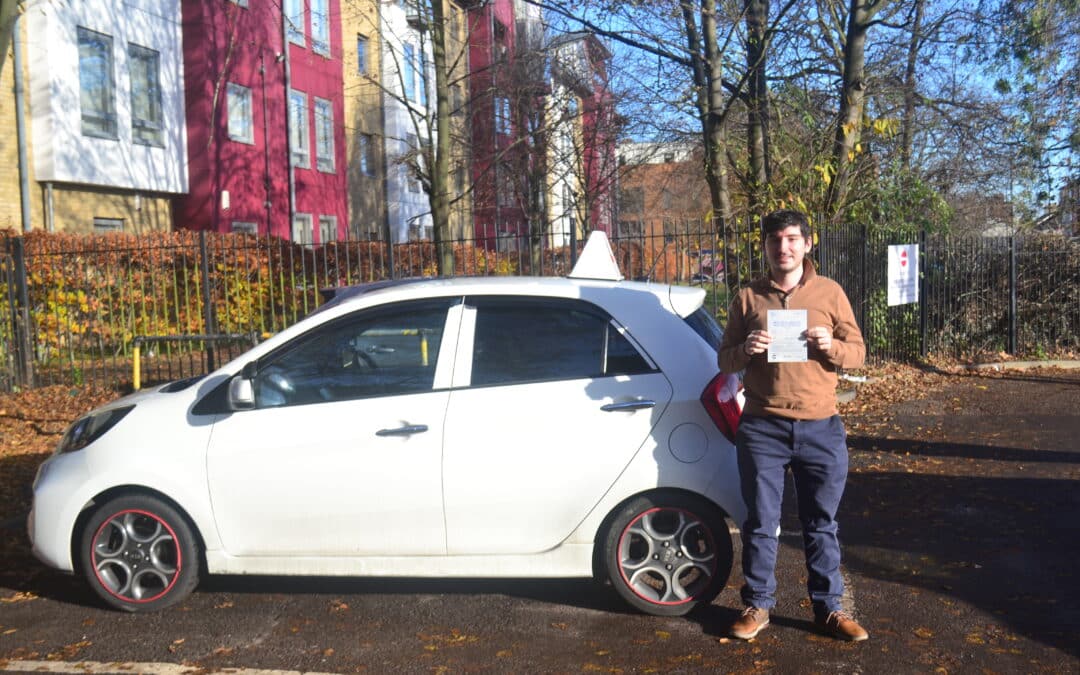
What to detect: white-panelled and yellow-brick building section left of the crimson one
<box><xmin>0</xmin><ymin>0</ymin><xmax>187</xmax><ymax>233</ymax></box>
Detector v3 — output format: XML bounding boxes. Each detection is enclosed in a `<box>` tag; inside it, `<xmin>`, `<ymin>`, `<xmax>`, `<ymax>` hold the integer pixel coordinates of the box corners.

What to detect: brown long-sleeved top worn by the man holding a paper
<box><xmin>717</xmin><ymin>259</ymin><xmax>866</xmax><ymax>419</ymax></box>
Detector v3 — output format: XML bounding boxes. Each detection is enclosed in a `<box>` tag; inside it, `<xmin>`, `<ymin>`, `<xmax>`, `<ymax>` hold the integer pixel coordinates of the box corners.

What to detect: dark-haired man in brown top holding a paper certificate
<box><xmin>718</xmin><ymin>211</ymin><xmax>867</xmax><ymax>640</ymax></box>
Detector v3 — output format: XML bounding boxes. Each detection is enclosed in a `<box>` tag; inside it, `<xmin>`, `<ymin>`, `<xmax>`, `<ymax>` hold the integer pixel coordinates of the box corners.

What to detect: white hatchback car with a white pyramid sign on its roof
<box><xmin>28</xmin><ymin>234</ymin><xmax>744</xmax><ymax>616</ymax></box>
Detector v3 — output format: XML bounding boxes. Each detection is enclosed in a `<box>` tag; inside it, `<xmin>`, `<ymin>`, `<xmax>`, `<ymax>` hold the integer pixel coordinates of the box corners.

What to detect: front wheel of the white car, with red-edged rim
<box><xmin>79</xmin><ymin>495</ymin><xmax>199</xmax><ymax>611</ymax></box>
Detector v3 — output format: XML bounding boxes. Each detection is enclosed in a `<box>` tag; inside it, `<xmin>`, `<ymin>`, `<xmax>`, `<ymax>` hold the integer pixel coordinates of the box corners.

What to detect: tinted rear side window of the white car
<box><xmin>468</xmin><ymin>297</ymin><xmax>652</xmax><ymax>386</ymax></box>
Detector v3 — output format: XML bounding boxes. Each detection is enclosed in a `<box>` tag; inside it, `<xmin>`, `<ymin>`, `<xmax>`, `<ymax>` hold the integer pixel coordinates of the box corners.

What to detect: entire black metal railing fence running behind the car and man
<box><xmin>0</xmin><ymin>224</ymin><xmax>1080</xmax><ymax>390</ymax></box>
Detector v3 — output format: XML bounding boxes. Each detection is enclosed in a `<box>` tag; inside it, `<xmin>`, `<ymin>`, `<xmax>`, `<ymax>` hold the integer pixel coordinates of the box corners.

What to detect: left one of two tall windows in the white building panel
<box><xmin>78</xmin><ymin>26</ymin><xmax>117</xmax><ymax>139</ymax></box>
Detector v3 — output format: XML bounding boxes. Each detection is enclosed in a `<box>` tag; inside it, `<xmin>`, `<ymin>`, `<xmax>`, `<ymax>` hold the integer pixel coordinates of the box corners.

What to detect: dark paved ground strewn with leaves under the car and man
<box><xmin>0</xmin><ymin>373</ymin><xmax>1080</xmax><ymax>675</ymax></box>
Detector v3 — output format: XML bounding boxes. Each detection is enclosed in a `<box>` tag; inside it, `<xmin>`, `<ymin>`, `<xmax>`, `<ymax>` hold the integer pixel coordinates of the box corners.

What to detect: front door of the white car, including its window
<box><xmin>207</xmin><ymin>298</ymin><xmax>461</xmax><ymax>556</ymax></box>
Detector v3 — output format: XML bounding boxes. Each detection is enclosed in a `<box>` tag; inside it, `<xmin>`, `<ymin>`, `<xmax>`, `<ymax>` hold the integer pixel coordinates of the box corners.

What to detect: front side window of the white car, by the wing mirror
<box><xmin>255</xmin><ymin>298</ymin><xmax>451</xmax><ymax>408</ymax></box>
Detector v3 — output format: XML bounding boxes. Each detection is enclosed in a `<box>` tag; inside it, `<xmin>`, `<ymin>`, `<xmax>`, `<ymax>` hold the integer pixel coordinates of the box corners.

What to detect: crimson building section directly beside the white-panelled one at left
<box><xmin>174</xmin><ymin>0</ymin><xmax>349</xmax><ymax>243</ymax></box>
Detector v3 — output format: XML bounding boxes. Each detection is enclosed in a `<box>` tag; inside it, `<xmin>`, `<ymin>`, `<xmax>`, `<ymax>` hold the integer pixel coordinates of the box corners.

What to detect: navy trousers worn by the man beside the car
<box><xmin>735</xmin><ymin>415</ymin><xmax>848</xmax><ymax>617</ymax></box>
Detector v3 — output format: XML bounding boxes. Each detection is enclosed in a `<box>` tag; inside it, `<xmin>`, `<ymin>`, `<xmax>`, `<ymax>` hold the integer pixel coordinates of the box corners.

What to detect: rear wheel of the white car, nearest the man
<box><xmin>604</xmin><ymin>492</ymin><xmax>732</xmax><ymax>617</ymax></box>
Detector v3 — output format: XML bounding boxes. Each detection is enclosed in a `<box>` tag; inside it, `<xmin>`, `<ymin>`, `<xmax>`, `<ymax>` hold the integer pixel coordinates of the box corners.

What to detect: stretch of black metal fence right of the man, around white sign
<box><xmin>818</xmin><ymin>226</ymin><xmax>1080</xmax><ymax>362</ymax></box>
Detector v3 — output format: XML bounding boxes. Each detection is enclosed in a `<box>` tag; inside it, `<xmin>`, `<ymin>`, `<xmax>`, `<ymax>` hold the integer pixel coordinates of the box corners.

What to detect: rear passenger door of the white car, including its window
<box><xmin>444</xmin><ymin>297</ymin><xmax>672</xmax><ymax>554</ymax></box>
